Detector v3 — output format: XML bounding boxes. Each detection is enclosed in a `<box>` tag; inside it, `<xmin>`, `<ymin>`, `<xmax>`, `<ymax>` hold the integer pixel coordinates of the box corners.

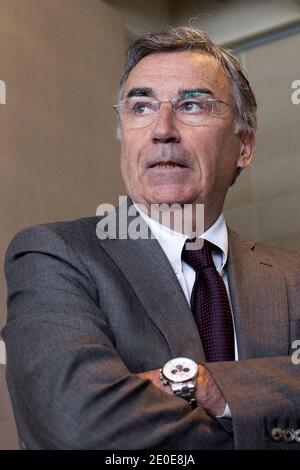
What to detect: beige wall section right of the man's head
<box><xmin>226</xmin><ymin>34</ymin><xmax>300</xmax><ymax>251</ymax></box>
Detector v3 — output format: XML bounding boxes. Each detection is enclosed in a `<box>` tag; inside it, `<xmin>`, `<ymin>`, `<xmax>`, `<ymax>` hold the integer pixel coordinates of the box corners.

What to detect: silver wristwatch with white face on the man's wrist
<box><xmin>159</xmin><ymin>357</ymin><xmax>198</xmax><ymax>408</ymax></box>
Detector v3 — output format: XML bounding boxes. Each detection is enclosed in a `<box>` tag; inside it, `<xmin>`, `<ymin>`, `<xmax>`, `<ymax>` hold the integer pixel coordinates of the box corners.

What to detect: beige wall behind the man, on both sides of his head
<box><xmin>0</xmin><ymin>0</ymin><xmax>300</xmax><ymax>449</ymax></box>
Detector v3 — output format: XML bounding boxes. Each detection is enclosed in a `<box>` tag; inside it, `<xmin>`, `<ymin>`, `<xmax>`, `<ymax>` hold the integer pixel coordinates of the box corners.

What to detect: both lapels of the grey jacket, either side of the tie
<box><xmin>98</xmin><ymin>198</ymin><xmax>289</xmax><ymax>362</ymax></box>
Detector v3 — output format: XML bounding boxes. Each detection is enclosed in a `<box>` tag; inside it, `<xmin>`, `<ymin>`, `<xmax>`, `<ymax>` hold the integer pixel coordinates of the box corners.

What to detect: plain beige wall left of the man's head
<box><xmin>0</xmin><ymin>0</ymin><xmax>124</xmax><ymax>449</ymax></box>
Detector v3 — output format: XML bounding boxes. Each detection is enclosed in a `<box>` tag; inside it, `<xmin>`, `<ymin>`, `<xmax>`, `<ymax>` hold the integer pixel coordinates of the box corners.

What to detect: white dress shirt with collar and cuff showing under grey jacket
<box><xmin>134</xmin><ymin>204</ymin><xmax>238</xmax><ymax>418</ymax></box>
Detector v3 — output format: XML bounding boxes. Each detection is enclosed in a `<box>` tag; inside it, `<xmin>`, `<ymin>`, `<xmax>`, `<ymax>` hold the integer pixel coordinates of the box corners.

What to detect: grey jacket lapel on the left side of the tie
<box><xmin>99</xmin><ymin>199</ymin><xmax>204</xmax><ymax>362</ymax></box>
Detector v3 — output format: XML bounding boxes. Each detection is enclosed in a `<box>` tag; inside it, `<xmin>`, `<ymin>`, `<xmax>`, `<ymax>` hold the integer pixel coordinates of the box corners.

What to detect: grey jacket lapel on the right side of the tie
<box><xmin>228</xmin><ymin>230</ymin><xmax>289</xmax><ymax>359</ymax></box>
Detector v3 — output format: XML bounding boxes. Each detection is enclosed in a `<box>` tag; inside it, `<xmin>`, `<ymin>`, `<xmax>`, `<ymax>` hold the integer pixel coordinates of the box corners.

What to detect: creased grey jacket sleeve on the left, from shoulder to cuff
<box><xmin>2</xmin><ymin>225</ymin><xmax>233</xmax><ymax>450</ymax></box>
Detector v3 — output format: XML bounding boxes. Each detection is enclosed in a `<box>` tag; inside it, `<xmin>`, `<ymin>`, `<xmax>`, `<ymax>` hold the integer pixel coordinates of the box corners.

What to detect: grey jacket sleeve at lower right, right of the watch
<box><xmin>205</xmin><ymin>355</ymin><xmax>300</xmax><ymax>450</ymax></box>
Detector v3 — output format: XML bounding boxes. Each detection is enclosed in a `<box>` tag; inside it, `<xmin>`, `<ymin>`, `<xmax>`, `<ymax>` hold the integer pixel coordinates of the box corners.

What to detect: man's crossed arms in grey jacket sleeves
<box><xmin>3</xmin><ymin>227</ymin><xmax>300</xmax><ymax>450</ymax></box>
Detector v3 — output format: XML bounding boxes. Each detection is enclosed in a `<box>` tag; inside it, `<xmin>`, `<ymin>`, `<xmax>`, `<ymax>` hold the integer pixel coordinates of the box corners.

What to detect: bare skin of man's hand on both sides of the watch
<box><xmin>137</xmin><ymin>365</ymin><xmax>226</xmax><ymax>417</ymax></box>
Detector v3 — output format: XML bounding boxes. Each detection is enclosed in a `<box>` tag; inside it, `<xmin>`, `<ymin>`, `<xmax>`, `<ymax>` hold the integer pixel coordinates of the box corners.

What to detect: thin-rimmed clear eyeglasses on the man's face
<box><xmin>114</xmin><ymin>94</ymin><xmax>234</xmax><ymax>129</ymax></box>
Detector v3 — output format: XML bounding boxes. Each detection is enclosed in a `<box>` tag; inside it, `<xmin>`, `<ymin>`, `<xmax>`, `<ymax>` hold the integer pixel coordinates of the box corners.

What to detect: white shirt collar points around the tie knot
<box><xmin>133</xmin><ymin>202</ymin><xmax>228</xmax><ymax>271</ymax></box>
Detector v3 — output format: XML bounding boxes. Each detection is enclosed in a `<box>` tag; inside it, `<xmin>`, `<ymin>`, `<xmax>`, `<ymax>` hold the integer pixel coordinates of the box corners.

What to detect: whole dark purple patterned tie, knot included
<box><xmin>182</xmin><ymin>240</ymin><xmax>234</xmax><ymax>362</ymax></box>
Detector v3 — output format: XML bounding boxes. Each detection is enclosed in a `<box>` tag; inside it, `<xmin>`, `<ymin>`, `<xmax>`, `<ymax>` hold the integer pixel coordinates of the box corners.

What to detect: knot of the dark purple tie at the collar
<box><xmin>182</xmin><ymin>238</ymin><xmax>214</xmax><ymax>271</ymax></box>
